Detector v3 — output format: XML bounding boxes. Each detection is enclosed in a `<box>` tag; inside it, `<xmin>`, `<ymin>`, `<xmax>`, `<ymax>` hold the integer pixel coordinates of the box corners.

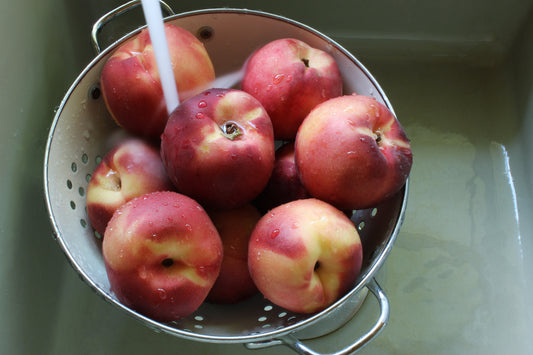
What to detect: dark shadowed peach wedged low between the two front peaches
<box><xmin>207</xmin><ymin>205</ymin><xmax>261</xmax><ymax>303</ymax></box>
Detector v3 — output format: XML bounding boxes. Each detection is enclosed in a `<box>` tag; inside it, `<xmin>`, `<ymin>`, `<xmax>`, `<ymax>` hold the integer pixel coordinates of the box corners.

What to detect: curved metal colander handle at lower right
<box><xmin>246</xmin><ymin>278</ymin><xmax>390</xmax><ymax>355</ymax></box>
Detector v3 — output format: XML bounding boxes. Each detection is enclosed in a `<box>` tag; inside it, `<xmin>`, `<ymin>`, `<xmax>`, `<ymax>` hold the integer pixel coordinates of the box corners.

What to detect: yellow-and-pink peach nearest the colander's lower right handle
<box><xmin>248</xmin><ymin>198</ymin><xmax>363</xmax><ymax>313</ymax></box>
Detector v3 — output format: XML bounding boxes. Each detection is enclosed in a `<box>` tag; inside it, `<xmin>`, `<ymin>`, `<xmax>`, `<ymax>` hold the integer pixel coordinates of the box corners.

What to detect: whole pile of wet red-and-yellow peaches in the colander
<box><xmin>87</xmin><ymin>24</ymin><xmax>412</xmax><ymax>322</ymax></box>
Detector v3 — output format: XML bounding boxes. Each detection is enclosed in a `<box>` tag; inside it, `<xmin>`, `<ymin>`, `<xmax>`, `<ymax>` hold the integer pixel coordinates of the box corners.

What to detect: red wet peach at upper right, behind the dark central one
<box><xmin>241</xmin><ymin>38</ymin><xmax>343</xmax><ymax>140</ymax></box>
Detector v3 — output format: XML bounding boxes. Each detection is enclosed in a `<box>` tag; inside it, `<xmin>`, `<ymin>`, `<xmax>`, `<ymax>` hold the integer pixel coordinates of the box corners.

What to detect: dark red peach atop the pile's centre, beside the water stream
<box><xmin>161</xmin><ymin>89</ymin><xmax>275</xmax><ymax>209</ymax></box>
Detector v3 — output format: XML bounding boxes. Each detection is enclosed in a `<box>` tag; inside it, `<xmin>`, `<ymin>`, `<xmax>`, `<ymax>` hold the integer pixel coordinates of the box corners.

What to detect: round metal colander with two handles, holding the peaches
<box><xmin>44</xmin><ymin>1</ymin><xmax>408</xmax><ymax>354</ymax></box>
